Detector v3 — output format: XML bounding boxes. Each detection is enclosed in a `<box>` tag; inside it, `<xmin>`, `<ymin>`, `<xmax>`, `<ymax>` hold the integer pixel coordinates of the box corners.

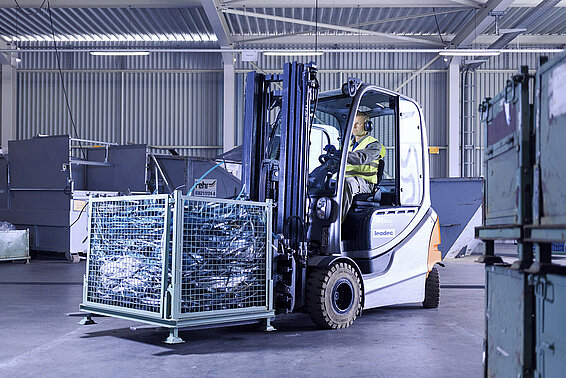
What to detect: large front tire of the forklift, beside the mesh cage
<box><xmin>306</xmin><ymin>263</ymin><xmax>362</xmax><ymax>329</ymax></box>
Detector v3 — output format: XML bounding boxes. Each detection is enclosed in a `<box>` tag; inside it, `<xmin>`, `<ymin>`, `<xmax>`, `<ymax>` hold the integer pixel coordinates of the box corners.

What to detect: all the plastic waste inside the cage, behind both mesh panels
<box><xmin>87</xmin><ymin>196</ymin><xmax>267</xmax><ymax>313</ymax></box>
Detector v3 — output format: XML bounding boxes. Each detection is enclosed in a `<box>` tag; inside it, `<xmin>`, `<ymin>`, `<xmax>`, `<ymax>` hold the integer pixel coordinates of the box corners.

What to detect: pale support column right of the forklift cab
<box><xmin>446</xmin><ymin>57</ymin><xmax>461</xmax><ymax>177</ymax></box>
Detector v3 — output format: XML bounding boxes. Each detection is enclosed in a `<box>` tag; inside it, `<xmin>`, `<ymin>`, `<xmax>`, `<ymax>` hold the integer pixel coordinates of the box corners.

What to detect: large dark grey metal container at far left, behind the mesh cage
<box><xmin>0</xmin><ymin>135</ymin><xmax>120</xmax><ymax>254</ymax></box>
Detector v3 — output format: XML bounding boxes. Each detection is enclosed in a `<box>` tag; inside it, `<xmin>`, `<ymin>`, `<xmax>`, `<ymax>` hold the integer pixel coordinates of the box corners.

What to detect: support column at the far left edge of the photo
<box><xmin>0</xmin><ymin>64</ymin><xmax>16</xmax><ymax>153</ymax></box>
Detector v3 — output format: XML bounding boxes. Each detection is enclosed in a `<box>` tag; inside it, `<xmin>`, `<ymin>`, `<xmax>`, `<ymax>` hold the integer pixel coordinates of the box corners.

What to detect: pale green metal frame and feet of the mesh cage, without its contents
<box><xmin>80</xmin><ymin>191</ymin><xmax>275</xmax><ymax>342</ymax></box>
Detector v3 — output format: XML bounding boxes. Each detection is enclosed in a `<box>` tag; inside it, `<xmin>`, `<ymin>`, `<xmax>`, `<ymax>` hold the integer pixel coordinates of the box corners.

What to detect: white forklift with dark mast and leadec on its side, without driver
<box><xmin>242</xmin><ymin>62</ymin><xmax>442</xmax><ymax>329</ymax></box>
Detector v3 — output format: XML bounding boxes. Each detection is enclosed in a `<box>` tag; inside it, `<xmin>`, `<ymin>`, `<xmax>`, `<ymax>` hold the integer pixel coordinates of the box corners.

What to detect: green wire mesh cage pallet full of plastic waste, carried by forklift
<box><xmin>80</xmin><ymin>191</ymin><xmax>274</xmax><ymax>343</ymax></box>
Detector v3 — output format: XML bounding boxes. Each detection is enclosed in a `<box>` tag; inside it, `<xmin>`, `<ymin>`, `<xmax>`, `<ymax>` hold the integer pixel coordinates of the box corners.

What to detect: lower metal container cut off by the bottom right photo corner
<box><xmin>532</xmin><ymin>274</ymin><xmax>566</xmax><ymax>377</ymax></box>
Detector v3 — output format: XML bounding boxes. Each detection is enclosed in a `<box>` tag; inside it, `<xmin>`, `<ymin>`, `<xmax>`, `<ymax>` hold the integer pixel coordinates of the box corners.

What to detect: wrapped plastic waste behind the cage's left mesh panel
<box><xmin>88</xmin><ymin>199</ymin><xmax>169</xmax><ymax>312</ymax></box>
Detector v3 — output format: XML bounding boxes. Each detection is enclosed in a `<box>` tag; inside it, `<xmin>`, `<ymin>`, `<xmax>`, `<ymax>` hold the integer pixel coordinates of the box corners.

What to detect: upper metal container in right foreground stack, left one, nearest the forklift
<box><xmin>482</xmin><ymin>67</ymin><xmax>532</xmax><ymax>226</ymax></box>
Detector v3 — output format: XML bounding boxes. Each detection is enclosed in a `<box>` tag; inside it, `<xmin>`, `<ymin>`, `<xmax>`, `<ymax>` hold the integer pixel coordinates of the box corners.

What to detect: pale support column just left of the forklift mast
<box><xmin>222</xmin><ymin>53</ymin><xmax>236</xmax><ymax>152</ymax></box>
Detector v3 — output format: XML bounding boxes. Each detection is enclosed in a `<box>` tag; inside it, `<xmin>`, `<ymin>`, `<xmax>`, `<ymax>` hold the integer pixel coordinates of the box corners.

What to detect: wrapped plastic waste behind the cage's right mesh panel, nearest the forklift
<box><xmin>181</xmin><ymin>201</ymin><xmax>267</xmax><ymax>312</ymax></box>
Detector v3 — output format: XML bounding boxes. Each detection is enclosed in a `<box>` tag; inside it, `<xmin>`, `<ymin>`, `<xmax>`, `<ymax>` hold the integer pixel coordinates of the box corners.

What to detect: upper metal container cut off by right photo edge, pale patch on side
<box><xmin>534</xmin><ymin>53</ymin><xmax>566</xmax><ymax>225</ymax></box>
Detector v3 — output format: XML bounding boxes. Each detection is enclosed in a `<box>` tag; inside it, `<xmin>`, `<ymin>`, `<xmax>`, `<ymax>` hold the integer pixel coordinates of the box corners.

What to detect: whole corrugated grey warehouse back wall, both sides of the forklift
<box><xmin>11</xmin><ymin>45</ymin><xmax>560</xmax><ymax>177</ymax></box>
